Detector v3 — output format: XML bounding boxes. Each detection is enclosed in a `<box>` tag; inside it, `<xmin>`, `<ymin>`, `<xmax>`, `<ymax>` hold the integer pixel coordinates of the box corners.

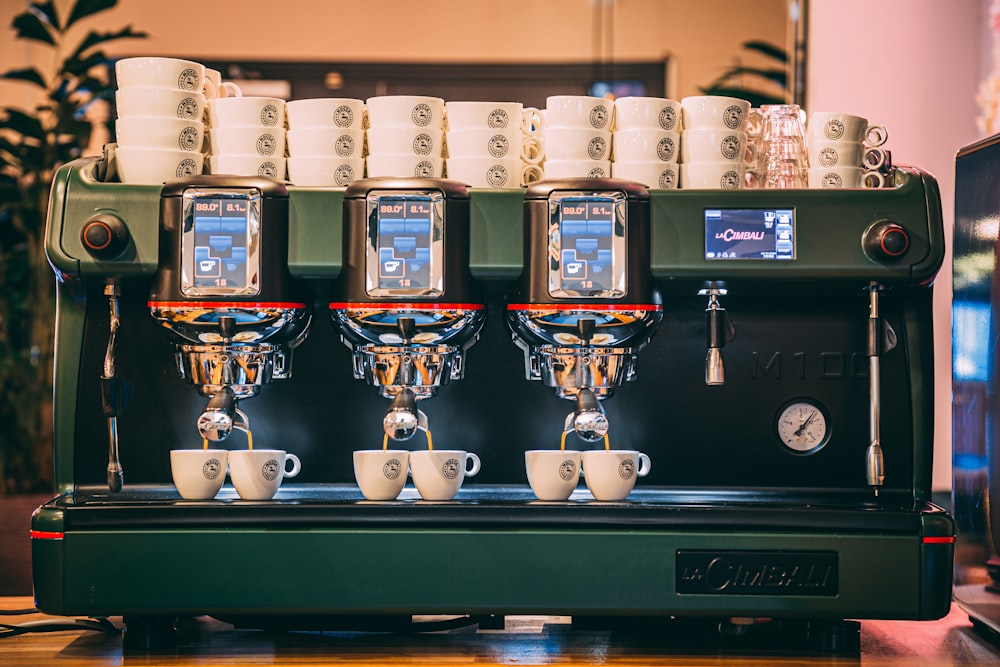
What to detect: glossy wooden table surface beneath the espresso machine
<box><xmin>0</xmin><ymin>597</ymin><xmax>1000</xmax><ymax>667</ymax></box>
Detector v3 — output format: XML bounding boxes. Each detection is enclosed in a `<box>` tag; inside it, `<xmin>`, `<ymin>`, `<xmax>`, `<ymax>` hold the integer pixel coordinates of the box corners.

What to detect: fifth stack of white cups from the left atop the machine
<box><xmin>445</xmin><ymin>102</ymin><xmax>545</xmax><ymax>188</ymax></box>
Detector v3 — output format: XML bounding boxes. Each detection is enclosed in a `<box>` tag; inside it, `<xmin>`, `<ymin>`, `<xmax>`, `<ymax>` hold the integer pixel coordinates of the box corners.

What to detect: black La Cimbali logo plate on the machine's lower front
<box><xmin>676</xmin><ymin>550</ymin><xmax>839</xmax><ymax>596</ymax></box>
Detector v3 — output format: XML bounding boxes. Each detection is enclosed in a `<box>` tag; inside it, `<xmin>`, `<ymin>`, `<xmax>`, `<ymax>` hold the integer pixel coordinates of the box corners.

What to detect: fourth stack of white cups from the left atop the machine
<box><xmin>365</xmin><ymin>95</ymin><xmax>444</xmax><ymax>178</ymax></box>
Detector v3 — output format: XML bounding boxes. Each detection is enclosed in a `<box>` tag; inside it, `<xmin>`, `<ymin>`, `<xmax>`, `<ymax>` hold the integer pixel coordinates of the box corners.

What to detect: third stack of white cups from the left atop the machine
<box><xmin>285</xmin><ymin>97</ymin><xmax>365</xmax><ymax>188</ymax></box>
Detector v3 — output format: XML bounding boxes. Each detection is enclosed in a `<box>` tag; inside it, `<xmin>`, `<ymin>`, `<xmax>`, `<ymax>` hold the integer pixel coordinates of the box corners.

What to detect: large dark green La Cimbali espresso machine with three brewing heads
<box><xmin>31</xmin><ymin>150</ymin><xmax>955</xmax><ymax>645</ymax></box>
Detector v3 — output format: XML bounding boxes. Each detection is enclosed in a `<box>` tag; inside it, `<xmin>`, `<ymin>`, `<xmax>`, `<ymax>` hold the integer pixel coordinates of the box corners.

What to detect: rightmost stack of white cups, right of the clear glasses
<box><xmin>808</xmin><ymin>111</ymin><xmax>889</xmax><ymax>189</ymax></box>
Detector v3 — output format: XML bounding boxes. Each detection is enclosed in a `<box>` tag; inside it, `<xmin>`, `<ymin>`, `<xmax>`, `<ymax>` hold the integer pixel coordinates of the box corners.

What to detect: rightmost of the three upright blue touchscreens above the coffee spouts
<box><xmin>559</xmin><ymin>197</ymin><xmax>615</xmax><ymax>292</ymax></box>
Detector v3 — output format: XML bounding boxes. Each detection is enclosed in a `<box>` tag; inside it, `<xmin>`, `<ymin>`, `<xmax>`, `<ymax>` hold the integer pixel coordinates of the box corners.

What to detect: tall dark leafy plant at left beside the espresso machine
<box><xmin>0</xmin><ymin>0</ymin><xmax>146</xmax><ymax>496</ymax></box>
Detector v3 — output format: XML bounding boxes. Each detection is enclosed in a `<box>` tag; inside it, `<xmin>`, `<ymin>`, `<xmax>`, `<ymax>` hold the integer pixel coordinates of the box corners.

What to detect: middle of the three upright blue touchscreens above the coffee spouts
<box><xmin>375</xmin><ymin>195</ymin><xmax>434</xmax><ymax>289</ymax></box>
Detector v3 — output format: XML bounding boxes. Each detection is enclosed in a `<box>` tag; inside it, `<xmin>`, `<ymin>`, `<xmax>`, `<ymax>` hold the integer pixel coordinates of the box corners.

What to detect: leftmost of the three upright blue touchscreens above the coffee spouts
<box><xmin>192</xmin><ymin>197</ymin><xmax>256</xmax><ymax>288</ymax></box>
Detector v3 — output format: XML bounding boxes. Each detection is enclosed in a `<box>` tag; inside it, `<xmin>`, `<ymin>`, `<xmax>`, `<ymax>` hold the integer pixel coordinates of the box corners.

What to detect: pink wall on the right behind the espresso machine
<box><xmin>806</xmin><ymin>0</ymin><xmax>992</xmax><ymax>489</ymax></box>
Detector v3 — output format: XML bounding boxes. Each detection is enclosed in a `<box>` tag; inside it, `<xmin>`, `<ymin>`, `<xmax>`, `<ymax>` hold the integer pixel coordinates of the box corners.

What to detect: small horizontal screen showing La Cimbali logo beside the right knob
<box><xmin>705</xmin><ymin>208</ymin><xmax>795</xmax><ymax>260</ymax></box>
